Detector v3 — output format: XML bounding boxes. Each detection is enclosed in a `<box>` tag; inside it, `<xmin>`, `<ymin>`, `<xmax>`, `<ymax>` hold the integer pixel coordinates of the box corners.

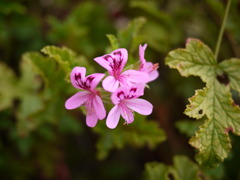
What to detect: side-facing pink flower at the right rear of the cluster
<box><xmin>139</xmin><ymin>44</ymin><xmax>159</xmax><ymax>82</ymax></box>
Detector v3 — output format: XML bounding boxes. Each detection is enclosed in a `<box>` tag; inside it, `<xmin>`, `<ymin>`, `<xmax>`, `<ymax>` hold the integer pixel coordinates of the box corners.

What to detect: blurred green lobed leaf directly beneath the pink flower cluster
<box><xmin>93</xmin><ymin>114</ymin><xmax>166</xmax><ymax>159</ymax></box>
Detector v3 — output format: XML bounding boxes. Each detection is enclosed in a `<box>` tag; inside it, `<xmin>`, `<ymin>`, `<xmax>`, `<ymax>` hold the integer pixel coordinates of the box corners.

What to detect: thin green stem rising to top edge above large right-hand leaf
<box><xmin>214</xmin><ymin>0</ymin><xmax>232</xmax><ymax>59</ymax></box>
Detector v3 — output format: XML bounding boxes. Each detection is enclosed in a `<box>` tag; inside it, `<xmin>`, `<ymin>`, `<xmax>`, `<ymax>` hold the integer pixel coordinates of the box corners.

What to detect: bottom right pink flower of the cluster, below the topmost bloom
<box><xmin>106</xmin><ymin>85</ymin><xmax>153</xmax><ymax>129</ymax></box>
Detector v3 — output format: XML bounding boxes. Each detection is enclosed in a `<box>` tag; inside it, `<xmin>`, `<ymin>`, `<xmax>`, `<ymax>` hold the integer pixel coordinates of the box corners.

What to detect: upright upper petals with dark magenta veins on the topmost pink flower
<box><xmin>94</xmin><ymin>48</ymin><xmax>128</xmax><ymax>75</ymax></box>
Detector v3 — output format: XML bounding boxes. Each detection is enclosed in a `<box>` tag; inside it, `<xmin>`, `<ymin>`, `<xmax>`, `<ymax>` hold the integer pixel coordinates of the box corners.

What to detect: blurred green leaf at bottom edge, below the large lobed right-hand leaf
<box><xmin>145</xmin><ymin>155</ymin><xmax>201</xmax><ymax>180</ymax></box>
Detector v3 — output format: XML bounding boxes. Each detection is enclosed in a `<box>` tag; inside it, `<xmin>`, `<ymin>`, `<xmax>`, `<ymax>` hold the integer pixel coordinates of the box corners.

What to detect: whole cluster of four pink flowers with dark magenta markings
<box><xmin>65</xmin><ymin>44</ymin><xmax>159</xmax><ymax>129</ymax></box>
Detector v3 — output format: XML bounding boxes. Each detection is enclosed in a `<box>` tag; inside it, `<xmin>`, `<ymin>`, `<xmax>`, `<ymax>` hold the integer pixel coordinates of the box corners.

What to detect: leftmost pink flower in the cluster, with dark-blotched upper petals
<box><xmin>65</xmin><ymin>67</ymin><xmax>106</xmax><ymax>127</ymax></box>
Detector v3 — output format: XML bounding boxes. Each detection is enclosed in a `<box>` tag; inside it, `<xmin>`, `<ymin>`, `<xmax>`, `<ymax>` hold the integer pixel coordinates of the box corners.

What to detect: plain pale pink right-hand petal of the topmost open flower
<box><xmin>119</xmin><ymin>70</ymin><xmax>149</xmax><ymax>86</ymax></box>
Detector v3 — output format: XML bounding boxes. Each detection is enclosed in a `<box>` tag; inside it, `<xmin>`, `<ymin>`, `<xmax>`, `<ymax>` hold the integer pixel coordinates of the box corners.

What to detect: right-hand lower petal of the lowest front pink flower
<box><xmin>124</xmin><ymin>98</ymin><xmax>153</xmax><ymax>115</ymax></box>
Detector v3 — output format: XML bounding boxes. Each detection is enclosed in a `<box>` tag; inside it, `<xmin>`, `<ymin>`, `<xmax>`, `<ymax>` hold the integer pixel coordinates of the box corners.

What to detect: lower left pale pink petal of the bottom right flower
<box><xmin>106</xmin><ymin>105</ymin><xmax>121</xmax><ymax>129</ymax></box>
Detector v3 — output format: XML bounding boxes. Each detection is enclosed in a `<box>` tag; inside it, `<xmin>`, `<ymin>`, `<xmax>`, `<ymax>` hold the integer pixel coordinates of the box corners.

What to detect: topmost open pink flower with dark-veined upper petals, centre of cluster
<box><xmin>94</xmin><ymin>48</ymin><xmax>148</xmax><ymax>92</ymax></box>
